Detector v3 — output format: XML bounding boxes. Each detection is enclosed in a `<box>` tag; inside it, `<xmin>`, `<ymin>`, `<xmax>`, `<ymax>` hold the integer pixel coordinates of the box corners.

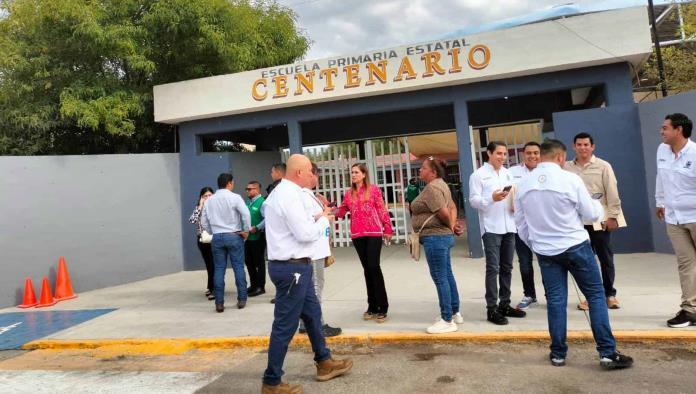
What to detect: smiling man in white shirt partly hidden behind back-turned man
<box><xmin>508</xmin><ymin>141</ymin><xmax>541</xmax><ymax>311</ymax></box>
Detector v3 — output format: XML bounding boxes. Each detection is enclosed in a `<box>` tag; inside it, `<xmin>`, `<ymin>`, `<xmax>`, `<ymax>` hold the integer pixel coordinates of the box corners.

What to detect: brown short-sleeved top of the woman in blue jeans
<box><xmin>411</xmin><ymin>178</ymin><xmax>453</xmax><ymax>236</ymax></box>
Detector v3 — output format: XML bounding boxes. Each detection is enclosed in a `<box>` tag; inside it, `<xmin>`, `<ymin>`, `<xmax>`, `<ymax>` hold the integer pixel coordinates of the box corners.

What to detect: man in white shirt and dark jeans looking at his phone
<box><xmin>469</xmin><ymin>141</ymin><xmax>526</xmax><ymax>325</ymax></box>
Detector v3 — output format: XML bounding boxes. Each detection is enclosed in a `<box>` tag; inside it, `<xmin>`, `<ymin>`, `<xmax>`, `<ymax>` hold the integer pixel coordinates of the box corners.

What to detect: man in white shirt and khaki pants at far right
<box><xmin>655</xmin><ymin>113</ymin><xmax>696</xmax><ymax>328</ymax></box>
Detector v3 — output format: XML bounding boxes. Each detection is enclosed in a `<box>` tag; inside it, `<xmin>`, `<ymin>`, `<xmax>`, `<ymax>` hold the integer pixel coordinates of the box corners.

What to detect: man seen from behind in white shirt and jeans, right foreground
<box><xmin>515</xmin><ymin>140</ymin><xmax>633</xmax><ymax>369</ymax></box>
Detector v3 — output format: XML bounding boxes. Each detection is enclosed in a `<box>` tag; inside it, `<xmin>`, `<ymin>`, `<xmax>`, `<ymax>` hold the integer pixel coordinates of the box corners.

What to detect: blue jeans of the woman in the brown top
<box><xmin>420</xmin><ymin>235</ymin><xmax>459</xmax><ymax>321</ymax></box>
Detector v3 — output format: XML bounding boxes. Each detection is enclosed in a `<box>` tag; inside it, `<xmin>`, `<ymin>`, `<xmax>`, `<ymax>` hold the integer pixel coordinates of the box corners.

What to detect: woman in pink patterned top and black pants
<box><xmin>336</xmin><ymin>164</ymin><xmax>394</xmax><ymax>323</ymax></box>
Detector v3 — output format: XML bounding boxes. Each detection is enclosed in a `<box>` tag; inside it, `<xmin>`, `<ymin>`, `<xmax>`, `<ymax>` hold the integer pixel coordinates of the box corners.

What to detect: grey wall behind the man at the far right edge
<box><xmin>638</xmin><ymin>92</ymin><xmax>696</xmax><ymax>253</ymax></box>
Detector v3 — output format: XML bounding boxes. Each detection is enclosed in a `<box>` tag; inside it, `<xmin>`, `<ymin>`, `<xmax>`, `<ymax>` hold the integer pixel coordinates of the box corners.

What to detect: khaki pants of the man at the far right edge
<box><xmin>667</xmin><ymin>223</ymin><xmax>696</xmax><ymax>313</ymax></box>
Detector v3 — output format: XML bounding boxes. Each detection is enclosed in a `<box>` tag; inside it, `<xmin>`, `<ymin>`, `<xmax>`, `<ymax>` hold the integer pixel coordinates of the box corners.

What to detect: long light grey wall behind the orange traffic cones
<box><xmin>0</xmin><ymin>154</ymin><xmax>182</xmax><ymax>307</ymax></box>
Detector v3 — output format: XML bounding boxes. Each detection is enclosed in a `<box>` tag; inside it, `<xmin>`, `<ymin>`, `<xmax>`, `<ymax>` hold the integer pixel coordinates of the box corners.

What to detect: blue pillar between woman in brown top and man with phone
<box><xmin>454</xmin><ymin>98</ymin><xmax>483</xmax><ymax>257</ymax></box>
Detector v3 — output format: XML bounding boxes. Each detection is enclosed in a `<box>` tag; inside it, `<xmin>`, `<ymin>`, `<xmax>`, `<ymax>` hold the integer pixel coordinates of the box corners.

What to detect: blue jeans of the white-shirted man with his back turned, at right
<box><xmin>537</xmin><ymin>241</ymin><xmax>616</xmax><ymax>358</ymax></box>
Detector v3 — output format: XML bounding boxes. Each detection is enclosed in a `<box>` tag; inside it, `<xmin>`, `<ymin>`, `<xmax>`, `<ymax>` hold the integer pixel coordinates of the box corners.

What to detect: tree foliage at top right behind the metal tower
<box><xmin>643</xmin><ymin>3</ymin><xmax>696</xmax><ymax>92</ymax></box>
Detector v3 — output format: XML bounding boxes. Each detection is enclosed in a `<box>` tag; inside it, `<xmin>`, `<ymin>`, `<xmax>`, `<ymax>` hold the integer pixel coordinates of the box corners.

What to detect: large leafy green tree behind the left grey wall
<box><xmin>0</xmin><ymin>0</ymin><xmax>309</xmax><ymax>154</ymax></box>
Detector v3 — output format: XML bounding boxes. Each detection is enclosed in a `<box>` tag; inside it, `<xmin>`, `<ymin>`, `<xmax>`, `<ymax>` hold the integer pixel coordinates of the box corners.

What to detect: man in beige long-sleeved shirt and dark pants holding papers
<box><xmin>564</xmin><ymin>133</ymin><xmax>626</xmax><ymax>310</ymax></box>
